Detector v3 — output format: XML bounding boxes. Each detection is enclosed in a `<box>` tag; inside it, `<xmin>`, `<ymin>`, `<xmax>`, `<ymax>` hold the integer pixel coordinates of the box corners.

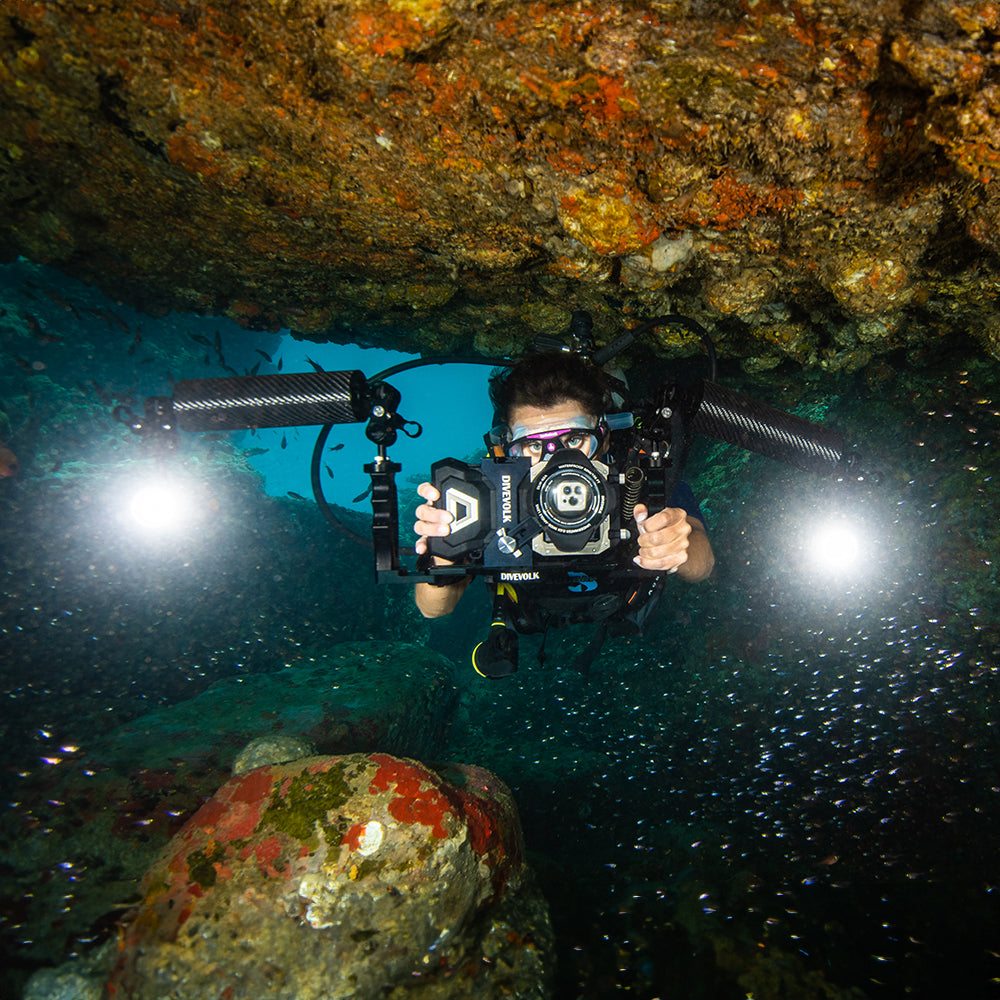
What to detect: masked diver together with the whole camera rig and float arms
<box><xmin>117</xmin><ymin>311</ymin><xmax>852</xmax><ymax>678</ymax></box>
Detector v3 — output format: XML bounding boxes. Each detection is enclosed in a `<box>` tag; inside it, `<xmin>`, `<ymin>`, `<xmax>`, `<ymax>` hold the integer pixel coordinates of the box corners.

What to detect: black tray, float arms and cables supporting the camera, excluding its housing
<box><xmin>114</xmin><ymin>312</ymin><xmax>856</xmax><ymax>584</ymax></box>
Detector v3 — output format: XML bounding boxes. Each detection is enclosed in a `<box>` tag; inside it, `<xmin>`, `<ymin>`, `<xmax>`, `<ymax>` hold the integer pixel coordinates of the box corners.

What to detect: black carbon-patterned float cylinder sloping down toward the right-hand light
<box><xmin>691</xmin><ymin>382</ymin><xmax>844</xmax><ymax>475</ymax></box>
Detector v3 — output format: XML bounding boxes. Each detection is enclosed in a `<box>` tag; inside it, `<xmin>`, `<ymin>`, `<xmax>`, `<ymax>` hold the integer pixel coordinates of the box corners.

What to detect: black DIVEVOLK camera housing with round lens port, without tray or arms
<box><xmin>427</xmin><ymin>448</ymin><xmax>616</xmax><ymax>569</ymax></box>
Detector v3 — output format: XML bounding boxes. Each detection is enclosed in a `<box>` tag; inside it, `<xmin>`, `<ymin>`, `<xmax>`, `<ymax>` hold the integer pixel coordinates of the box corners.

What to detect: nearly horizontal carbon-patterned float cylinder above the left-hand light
<box><xmin>173</xmin><ymin>371</ymin><xmax>368</xmax><ymax>431</ymax></box>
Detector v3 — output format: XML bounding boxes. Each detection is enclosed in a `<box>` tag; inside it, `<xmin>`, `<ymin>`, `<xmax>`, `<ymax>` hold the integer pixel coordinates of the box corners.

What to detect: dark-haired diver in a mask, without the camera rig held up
<box><xmin>414</xmin><ymin>352</ymin><xmax>715</xmax><ymax>676</ymax></box>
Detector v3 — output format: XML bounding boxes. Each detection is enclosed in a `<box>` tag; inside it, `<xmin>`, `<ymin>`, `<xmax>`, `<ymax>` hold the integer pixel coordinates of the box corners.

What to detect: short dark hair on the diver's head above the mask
<box><xmin>490</xmin><ymin>351</ymin><xmax>611</xmax><ymax>424</ymax></box>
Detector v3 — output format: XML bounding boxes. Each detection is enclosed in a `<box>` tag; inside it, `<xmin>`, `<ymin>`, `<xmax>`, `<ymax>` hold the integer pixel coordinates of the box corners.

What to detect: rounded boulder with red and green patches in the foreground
<box><xmin>108</xmin><ymin>753</ymin><xmax>553</xmax><ymax>1000</ymax></box>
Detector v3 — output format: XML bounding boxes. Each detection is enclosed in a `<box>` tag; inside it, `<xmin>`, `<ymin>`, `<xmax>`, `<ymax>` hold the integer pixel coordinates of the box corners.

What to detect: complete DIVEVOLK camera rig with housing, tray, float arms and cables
<box><xmin>114</xmin><ymin>313</ymin><xmax>856</xmax><ymax>583</ymax></box>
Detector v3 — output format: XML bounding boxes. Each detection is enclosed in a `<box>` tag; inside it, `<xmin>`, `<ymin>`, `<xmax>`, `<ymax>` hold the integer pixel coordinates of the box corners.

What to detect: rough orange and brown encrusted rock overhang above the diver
<box><xmin>0</xmin><ymin>0</ymin><xmax>1000</xmax><ymax>370</ymax></box>
